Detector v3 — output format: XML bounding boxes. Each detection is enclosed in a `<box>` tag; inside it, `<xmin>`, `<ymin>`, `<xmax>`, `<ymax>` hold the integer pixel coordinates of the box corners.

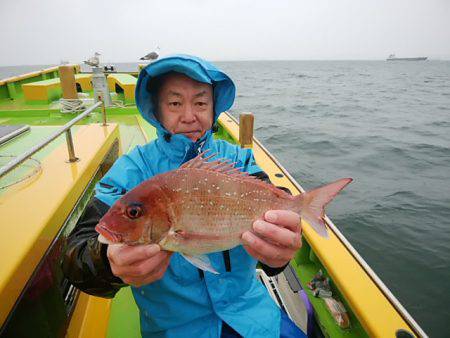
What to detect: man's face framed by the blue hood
<box><xmin>159</xmin><ymin>74</ymin><xmax>214</xmax><ymax>142</ymax></box>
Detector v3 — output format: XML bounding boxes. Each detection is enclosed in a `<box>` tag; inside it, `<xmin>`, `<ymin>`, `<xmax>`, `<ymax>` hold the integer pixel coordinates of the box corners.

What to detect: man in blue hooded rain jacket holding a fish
<box><xmin>63</xmin><ymin>55</ymin><xmax>301</xmax><ymax>337</ymax></box>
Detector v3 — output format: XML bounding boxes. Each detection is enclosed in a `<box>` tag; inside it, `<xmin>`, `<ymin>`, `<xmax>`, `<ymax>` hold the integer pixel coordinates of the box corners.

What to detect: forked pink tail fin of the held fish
<box><xmin>295</xmin><ymin>178</ymin><xmax>353</xmax><ymax>238</ymax></box>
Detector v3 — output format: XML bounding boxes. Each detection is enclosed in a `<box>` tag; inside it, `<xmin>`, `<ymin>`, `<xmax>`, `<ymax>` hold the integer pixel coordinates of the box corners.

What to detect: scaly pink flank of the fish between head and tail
<box><xmin>161</xmin><ymin>168</ymin><xmax>292</xmax><ymax>254</ymax></box>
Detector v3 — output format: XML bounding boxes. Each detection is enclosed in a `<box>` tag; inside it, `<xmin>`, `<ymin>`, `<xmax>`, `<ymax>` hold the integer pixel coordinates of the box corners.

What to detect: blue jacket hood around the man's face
<box><xmin>135</xmin><ymin>54</ymin><xmax>236</xmax><ymax>132</ymax></box>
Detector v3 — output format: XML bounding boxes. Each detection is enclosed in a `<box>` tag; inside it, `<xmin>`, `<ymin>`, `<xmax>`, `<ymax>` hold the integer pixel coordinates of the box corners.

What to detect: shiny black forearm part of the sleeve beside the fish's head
<box><xmin>62</xmin><ymin>197</ymin><xmax>126</xmax><ymax>298</ymax></box>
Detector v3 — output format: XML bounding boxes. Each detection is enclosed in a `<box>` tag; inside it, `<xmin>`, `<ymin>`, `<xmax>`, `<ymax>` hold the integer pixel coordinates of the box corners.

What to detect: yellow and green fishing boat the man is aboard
<box><xmin>0</xmin><ymin>65</ymin><xmax>426</xmax><ymax>337</ymax></box>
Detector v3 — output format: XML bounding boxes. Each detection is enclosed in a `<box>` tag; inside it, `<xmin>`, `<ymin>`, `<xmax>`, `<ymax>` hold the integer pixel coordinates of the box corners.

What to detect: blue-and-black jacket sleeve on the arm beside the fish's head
<box><xmin>62</xmin><ymin>150</ymin><xmax>144</xmax><ymax>298</ymax></box>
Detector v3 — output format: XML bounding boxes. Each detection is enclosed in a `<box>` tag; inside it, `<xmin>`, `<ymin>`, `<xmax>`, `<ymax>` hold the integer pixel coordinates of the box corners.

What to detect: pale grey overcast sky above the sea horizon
<box><xmin>0</xmin><ymin>0</ymin><xmax>450</xmax><ymax>66</ymax></box>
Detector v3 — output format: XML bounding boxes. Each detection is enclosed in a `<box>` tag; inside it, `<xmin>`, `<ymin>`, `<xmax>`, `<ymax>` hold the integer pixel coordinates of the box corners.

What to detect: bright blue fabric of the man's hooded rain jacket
<box><xmin>96</xmin><ymin>55</ymin><xmax>280</xmax><ymax>338</ymax></box>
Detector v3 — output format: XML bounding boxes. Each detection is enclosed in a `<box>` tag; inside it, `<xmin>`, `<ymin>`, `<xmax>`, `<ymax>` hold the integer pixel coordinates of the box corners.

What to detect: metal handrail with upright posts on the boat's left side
<box><xmin>0</xmin><ymin>101</ymin><xmax>106</xmax><ymax>178</ymax></box>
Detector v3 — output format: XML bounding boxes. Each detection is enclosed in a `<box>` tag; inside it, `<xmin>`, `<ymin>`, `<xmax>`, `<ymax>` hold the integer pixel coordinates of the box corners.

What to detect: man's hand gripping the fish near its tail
<box><xmin>242</xmin><ymin>210</ymin><xmax>302</xmax><ymax>268</ymax></box>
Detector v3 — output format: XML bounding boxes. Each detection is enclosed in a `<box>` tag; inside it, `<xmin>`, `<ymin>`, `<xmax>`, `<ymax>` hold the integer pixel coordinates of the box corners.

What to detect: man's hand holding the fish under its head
<box><xmin>107</xmin><ymin>244</ymin><xmax>172</xmax><ymax>287</ymax></box>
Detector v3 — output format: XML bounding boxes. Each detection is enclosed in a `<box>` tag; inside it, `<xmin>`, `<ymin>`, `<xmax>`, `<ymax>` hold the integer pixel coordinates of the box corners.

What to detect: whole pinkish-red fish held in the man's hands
<box><xmin>96</xmin><ymin>155</ymin><xmax>352</xmax><ymax>256</ymax></box>
